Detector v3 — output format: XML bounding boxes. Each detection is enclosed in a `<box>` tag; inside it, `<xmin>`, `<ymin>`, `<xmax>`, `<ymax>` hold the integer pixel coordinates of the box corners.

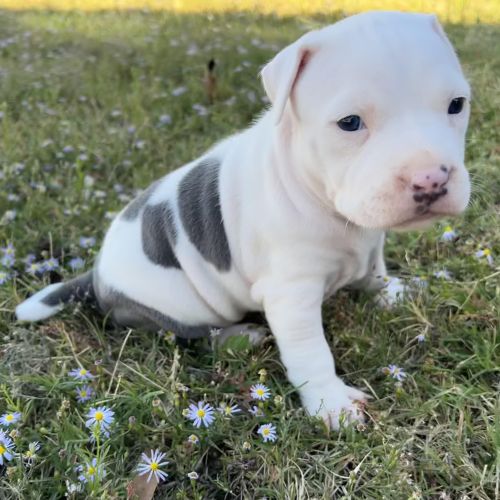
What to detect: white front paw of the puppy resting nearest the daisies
<box><xmin>304</xmin><ymin>380</ymin><xmax>369</xmax><ymax>430</ymax></box>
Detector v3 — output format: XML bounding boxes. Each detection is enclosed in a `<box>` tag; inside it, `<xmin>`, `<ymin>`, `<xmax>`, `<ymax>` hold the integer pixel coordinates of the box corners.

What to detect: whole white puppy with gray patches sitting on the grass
<box><xmin>16</xmin><ymin>12</ymin><xmax>470</xmax><ymax>427</ymax></box>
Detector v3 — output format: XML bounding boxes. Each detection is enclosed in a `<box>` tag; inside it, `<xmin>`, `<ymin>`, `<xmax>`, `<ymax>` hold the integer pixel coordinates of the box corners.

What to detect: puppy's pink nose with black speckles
<box><xmin>410</xmin><ymin>165</ymin><xmax>450</xmax><ymax>214</ymax></box>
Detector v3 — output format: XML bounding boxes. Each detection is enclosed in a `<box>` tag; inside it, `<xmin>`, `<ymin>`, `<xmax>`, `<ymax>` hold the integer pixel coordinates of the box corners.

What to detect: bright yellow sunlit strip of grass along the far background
<box><xmin>0</xmin><ymin>0</ymin><xmax>500</xmax><ymax>23</ymax></box>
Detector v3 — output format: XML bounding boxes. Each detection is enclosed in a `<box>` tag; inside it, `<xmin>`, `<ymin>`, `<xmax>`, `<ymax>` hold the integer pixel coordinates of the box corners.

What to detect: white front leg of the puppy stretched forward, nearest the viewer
<box><xmin>264</xmin><ymin>281</ymin><xmax>366</xmax><ymax>428</ymax></box>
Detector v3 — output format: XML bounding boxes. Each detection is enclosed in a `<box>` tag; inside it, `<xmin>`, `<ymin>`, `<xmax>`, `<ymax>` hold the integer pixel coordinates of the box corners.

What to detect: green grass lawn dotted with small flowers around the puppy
<box><xmin>0</xmin><ymin>7</ymin><xmax>500</xmax><ymax>500</ymax></box>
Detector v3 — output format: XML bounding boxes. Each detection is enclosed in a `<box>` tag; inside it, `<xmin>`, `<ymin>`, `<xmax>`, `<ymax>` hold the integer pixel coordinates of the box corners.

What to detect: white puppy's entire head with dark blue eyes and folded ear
<box><xmin>262</xmin><ymin>12</ymin><xmax>470</xmax><ymax>229</ymax></box>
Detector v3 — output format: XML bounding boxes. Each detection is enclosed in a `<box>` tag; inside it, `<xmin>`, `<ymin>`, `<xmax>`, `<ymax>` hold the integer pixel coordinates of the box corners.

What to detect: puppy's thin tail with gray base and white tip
<box><xmin>16</xmin><ymin>271</ymin><xmax>95</xmax><ymax>321</ymax></box>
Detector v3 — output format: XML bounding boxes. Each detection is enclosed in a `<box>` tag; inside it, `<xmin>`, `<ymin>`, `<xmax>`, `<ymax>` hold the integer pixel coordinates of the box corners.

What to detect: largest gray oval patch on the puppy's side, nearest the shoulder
<box><xmin>178</xmin><ymin>159</ymin><xmax>231</xmax><ymax>271</ymax></box>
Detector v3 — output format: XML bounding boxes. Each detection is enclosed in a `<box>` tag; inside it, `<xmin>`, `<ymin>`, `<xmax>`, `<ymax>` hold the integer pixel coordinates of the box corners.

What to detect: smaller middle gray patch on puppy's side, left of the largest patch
<box><xmin>142</xmin><ymin>201</ymin><xmax>181</xmax><ymax>269</ymax></box>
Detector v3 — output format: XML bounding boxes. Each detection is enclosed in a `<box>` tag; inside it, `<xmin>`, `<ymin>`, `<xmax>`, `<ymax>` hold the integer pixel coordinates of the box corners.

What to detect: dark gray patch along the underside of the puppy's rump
<box><xmin>101</xmin><ymin>291</ymin><xmax>213</xmax><ymax>339</ymax></box>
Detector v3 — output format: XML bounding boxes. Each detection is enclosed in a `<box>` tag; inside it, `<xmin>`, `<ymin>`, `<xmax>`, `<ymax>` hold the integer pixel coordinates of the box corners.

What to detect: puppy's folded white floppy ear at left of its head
<box><xmin>260</xmin><ymin>31</ymin><xmax>316</xmax><ymax>125</ymax></box>
